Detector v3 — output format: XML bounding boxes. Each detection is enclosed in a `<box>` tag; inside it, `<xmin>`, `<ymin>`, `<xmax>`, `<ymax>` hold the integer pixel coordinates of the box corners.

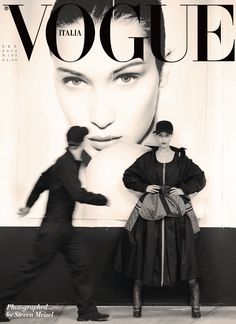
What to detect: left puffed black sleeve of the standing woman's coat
<box><xmin>123</xmin><ymin>153</ymin><xmax>148</xmax><ymax>192</ymax></box>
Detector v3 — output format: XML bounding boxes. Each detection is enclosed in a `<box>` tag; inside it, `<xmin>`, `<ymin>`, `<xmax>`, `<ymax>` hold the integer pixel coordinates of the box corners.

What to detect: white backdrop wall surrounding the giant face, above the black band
<box><xmin>0</xmin><ymin>0</ymin><xmax>236</xmax><ymax>227</ymax></box>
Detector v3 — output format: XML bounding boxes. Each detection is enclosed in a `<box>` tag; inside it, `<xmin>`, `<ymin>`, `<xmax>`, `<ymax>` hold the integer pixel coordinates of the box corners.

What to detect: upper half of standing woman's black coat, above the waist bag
<box><xmin>123</xmin><ymin>147</ymin><xmax>206</xmax><ymax>195</ymax></box>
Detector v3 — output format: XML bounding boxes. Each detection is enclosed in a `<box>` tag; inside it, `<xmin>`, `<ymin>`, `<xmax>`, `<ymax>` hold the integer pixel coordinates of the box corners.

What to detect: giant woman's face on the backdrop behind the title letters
<box><xmin>52</xmin><ymin>18</ymin><xmax>159</xmax><ymax>156</ymax></box>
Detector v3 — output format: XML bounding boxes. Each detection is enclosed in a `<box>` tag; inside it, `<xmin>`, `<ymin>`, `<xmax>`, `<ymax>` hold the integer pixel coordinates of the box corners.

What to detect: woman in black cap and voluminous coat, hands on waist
<box><xmin>115</xmin><ymin>120</ymin><xmax>206</xmax><ymax>318</ymax></box>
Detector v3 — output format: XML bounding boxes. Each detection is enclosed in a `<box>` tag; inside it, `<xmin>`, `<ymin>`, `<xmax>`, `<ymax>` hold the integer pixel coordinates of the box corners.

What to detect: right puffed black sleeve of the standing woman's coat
<box><xmin>179</xmin><ymin>157</ymin><xmax>206</xmax><ymax>195</ymax></box>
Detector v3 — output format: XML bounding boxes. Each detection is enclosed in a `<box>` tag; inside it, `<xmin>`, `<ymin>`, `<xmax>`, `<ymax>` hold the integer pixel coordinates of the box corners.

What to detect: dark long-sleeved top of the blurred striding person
<box><xmin>26</xmin><ymin>149</ymin><xmax>107</xmax><ymax>222</ymax></box>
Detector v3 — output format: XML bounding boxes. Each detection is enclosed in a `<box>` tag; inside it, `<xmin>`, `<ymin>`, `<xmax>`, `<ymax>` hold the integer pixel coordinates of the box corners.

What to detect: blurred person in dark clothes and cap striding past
<box><xmin>0</xmin><ymin>126</ymin><xmax>109</xmax><ymax>322</ymax></box>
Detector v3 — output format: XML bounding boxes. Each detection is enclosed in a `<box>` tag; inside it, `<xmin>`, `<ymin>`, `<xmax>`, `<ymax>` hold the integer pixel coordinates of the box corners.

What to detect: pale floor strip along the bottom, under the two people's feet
<box><xmin>3</xmin><ymin>305</ymin><xmax>236</xmax><ymax>324</ymax></box>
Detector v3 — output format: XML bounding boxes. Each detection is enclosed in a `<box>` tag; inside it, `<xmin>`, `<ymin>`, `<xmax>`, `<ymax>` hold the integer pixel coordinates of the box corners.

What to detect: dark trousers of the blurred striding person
<box><xmin>0</xmin><ymin>220</ymin><xmax>97</xmax><ymax>314</ymax></box>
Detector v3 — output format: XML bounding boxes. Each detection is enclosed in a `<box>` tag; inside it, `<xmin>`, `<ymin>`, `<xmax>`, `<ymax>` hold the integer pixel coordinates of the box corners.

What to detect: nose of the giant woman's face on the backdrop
<box><xmin>90</xmin><ymin>90</ymin><xmax>115</xmax><ymax>129</ymax></box>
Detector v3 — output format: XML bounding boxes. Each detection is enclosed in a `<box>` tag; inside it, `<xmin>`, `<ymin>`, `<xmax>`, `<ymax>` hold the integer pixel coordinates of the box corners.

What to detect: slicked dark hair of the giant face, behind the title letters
<box><xmin>52</xmin><ymin>0</ymin><xmax>165</xmax><ymax>74</ymax></box>
